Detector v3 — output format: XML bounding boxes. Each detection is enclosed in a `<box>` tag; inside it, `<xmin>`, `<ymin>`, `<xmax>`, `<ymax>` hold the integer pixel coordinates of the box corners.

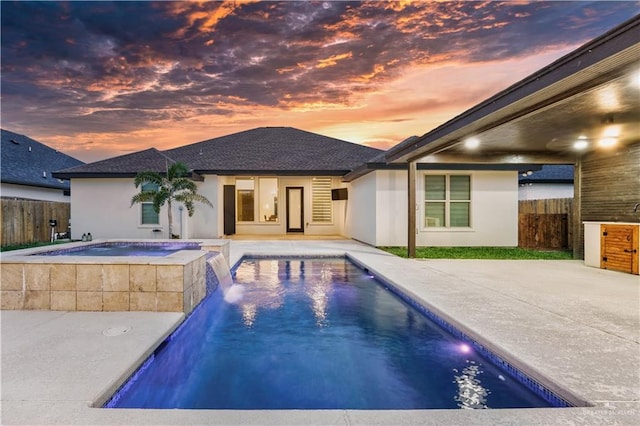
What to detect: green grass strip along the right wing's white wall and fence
<box><xmin>378</xmin><ymin>247</ymin><xmax>573</xmax><ymax>260</ymax></box>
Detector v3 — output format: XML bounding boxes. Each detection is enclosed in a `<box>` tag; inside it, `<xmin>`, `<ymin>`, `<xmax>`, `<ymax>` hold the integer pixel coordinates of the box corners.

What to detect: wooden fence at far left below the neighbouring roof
<box><xmin>0</xmin><ymin>198</ymin><xmax>71</xmax><ymax>246</ymax></box>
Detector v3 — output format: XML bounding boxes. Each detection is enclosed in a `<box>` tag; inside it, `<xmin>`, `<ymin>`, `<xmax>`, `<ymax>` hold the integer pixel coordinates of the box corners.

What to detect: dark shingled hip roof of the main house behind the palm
<box><xmin>56</xmin><ymin>127</ymin><xmax>384</xmax><ymax>178</ymax></box>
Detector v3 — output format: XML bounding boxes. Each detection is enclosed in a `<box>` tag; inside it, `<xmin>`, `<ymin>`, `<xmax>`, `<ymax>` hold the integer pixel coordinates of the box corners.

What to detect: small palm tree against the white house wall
<box><xmin>130</xmin><ymin>162</ymin><xmax>213</xmax><ymax>238</ymax></box>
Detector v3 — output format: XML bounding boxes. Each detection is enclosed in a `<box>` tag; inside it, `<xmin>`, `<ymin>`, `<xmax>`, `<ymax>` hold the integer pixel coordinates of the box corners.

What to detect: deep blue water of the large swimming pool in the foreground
<box><xmin>106</xmin><ymin>259</ymin><xmax>564</xmax><ymax>409</ymax></box>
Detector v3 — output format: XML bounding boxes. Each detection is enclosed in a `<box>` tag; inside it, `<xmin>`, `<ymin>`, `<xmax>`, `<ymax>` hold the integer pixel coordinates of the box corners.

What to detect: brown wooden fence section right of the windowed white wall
<box><xmin>518</xmin><ymin>198</ymin><xmax>573</xmax><ymax>249</ymax></box>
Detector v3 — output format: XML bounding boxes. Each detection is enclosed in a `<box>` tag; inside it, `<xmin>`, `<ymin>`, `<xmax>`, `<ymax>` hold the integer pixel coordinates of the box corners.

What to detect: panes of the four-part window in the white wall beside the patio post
<box><xmin>424</xmin><ymin>175</ymin><xmax>471</xmax><ymax>228</ymax></box>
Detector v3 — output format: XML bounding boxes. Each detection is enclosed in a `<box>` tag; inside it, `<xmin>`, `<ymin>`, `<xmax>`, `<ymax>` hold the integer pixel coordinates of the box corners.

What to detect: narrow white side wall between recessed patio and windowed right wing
<box><xmin>345</xmin><ymin>172</ymin><xmax>378</xmax><ymax>245</ymax></box>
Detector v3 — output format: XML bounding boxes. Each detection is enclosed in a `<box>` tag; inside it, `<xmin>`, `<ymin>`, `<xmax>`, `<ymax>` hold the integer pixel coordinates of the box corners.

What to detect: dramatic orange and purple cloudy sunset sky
<box><xmin>1</xmin><ymin>1</ymin><xmax>640</xmax><ymax>162</ymax></box>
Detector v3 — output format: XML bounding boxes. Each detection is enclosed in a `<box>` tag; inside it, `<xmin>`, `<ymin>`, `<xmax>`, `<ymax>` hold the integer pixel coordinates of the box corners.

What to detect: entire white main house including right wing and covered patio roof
<box><xmin>55</xmin><ymin>16</ymin><xmax>640</xmax><ymax>261</ymax></box>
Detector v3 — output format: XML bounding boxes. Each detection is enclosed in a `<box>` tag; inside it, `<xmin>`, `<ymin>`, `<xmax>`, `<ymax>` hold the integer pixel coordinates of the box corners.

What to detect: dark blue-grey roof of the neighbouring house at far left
<box><xmin>0</xmin><ymin>129</ymin><xmax>84</xmax><ymax>191</ymax></box>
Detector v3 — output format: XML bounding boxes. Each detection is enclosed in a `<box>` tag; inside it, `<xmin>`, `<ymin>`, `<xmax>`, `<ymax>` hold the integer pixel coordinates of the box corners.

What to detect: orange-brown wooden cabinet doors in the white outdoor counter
<box><xmin>600</xmin><ymin>224</ymin><xmax>640</xmax><ymax>274</ymax></box>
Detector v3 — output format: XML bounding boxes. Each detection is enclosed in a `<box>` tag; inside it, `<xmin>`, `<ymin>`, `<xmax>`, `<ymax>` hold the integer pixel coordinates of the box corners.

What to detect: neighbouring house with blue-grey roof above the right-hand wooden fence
<box><xmin>518</xmin><ymin>164</ymin><xmax>573</xmax><ymax>200</ymax></box>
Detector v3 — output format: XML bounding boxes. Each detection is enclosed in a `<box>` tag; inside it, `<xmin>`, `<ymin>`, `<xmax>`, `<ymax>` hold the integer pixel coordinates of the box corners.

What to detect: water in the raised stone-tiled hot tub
<box><xmin>34</xmin><ymin>242</ymin><xmax>200</xmax><ymax>257</ymax></box>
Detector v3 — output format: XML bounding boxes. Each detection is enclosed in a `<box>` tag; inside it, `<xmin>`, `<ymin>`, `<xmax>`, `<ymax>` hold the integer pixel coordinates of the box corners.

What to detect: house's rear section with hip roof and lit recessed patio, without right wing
<box><xmin>55</xmin><ymin>127</ymin><xmax>382</xmax><ymax>238</ymax></box>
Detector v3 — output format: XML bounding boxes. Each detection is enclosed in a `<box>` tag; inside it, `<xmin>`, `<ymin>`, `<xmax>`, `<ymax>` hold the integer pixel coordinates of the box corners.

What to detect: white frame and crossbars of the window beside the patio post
<box><xmin>417</xmin><ymin>170</ymin><xmax>474</xmax><ymax>232</ymax></box>
